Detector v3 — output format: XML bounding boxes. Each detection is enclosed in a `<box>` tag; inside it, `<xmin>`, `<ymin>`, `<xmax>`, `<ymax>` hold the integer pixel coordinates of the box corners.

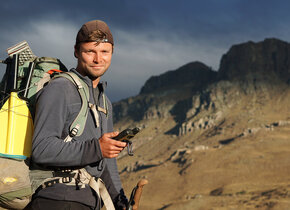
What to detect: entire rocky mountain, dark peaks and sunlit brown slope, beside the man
<box><xmin>113</xmin><ymin>39</ymin><xmax>290</xmax><ymax>209</ymax></box>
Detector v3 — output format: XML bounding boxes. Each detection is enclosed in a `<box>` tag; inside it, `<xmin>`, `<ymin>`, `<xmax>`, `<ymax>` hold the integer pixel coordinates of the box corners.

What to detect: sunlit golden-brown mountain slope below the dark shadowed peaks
<box><xmin>117</xmin><ymin>83</ymin><xmax>290</xmax><ymax>210</ymax></box>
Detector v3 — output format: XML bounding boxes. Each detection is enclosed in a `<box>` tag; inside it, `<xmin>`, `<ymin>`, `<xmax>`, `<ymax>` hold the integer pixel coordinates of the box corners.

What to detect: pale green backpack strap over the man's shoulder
<box><xmin>55</xmin><ymin>72</ymin><xmax>90</xmax><ymax>142</ymax></box>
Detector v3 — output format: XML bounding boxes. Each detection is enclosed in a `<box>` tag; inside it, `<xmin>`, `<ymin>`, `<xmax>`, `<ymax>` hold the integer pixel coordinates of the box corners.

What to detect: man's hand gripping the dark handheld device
<box><xmin>99</xmin><ymin>132</ymin><xmax>127</xmax><ymax>158</ymax></box>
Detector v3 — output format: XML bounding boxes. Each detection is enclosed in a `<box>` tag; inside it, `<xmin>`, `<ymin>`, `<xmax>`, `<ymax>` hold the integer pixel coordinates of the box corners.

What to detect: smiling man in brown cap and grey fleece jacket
<box><xmin>26</xmin><ymin>20</ymin><xmax>127</xmax><ymax>210</ymax></box>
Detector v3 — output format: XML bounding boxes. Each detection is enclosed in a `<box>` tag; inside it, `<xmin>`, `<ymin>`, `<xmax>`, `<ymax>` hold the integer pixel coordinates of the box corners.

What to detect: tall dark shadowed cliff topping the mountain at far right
<box><xmin>218</xmin><ymin>39</ymin><xmax>290</xmax><ymax>83</ymax></box>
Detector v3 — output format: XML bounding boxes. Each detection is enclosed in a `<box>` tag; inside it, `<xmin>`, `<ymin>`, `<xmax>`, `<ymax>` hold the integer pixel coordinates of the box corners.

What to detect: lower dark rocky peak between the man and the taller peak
<box><xmin>114</xmin><ymin>62</ymin><xmax>217</xmax><ymax>122</ymax></box>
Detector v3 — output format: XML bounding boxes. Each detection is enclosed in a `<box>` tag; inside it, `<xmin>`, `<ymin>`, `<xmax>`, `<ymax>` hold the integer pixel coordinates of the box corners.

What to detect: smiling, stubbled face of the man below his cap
<box><xmin>75</xmin><ymin>42</ymin><xmax>113</xmax><ymax>81</ymax></box>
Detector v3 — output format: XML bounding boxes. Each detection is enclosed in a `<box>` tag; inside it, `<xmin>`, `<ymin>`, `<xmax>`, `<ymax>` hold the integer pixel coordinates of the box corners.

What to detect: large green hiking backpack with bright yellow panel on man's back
<box><xmin>0</xmin><ymin>42</ymin><xmax>102</xmax><ymax>209</ymax></box>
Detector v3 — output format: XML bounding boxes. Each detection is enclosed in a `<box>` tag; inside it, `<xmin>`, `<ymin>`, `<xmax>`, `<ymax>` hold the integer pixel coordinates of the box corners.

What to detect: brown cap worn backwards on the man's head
<box><xmin>76</xmin><ymin>20</ymin><xmax>114</xmax><ymax>45</ymax></box>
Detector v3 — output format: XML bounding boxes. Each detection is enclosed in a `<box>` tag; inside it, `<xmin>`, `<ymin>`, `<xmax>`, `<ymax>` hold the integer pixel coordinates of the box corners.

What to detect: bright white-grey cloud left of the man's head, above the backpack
<box><xmin>0</xmin><ymin>20</ymin><xmax>78</xmax><ymax>87</ymax></box>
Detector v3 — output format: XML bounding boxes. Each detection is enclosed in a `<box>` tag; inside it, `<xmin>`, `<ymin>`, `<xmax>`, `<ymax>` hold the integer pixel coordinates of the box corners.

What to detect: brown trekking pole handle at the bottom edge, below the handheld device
<box><xmin>127</xmin><ymin>179</ymin><xmax>148</xmax><ymax>210</ymax></box>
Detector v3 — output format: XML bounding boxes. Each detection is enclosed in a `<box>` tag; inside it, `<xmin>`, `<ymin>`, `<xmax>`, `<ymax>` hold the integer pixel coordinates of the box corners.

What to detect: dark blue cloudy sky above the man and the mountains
<box><xmin>0</xmin><ymin>0</ymin><xmax>290</xmax><ymax>102</ymax></box>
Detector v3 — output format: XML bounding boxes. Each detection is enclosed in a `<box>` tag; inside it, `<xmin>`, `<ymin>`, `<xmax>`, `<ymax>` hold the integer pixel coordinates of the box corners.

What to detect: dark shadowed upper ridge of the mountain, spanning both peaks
<box><xmin>114</xmin><ymin>39</ymin><xmax>290</xmax><ymax>127</ymax></box>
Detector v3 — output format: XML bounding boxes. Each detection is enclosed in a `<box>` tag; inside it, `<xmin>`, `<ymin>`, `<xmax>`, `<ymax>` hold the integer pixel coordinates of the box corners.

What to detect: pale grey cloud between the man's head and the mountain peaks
<box><xmin>104</xmin><ymin>30</ymin><xmax>225</xmax><ymax>101</ymax></box>
